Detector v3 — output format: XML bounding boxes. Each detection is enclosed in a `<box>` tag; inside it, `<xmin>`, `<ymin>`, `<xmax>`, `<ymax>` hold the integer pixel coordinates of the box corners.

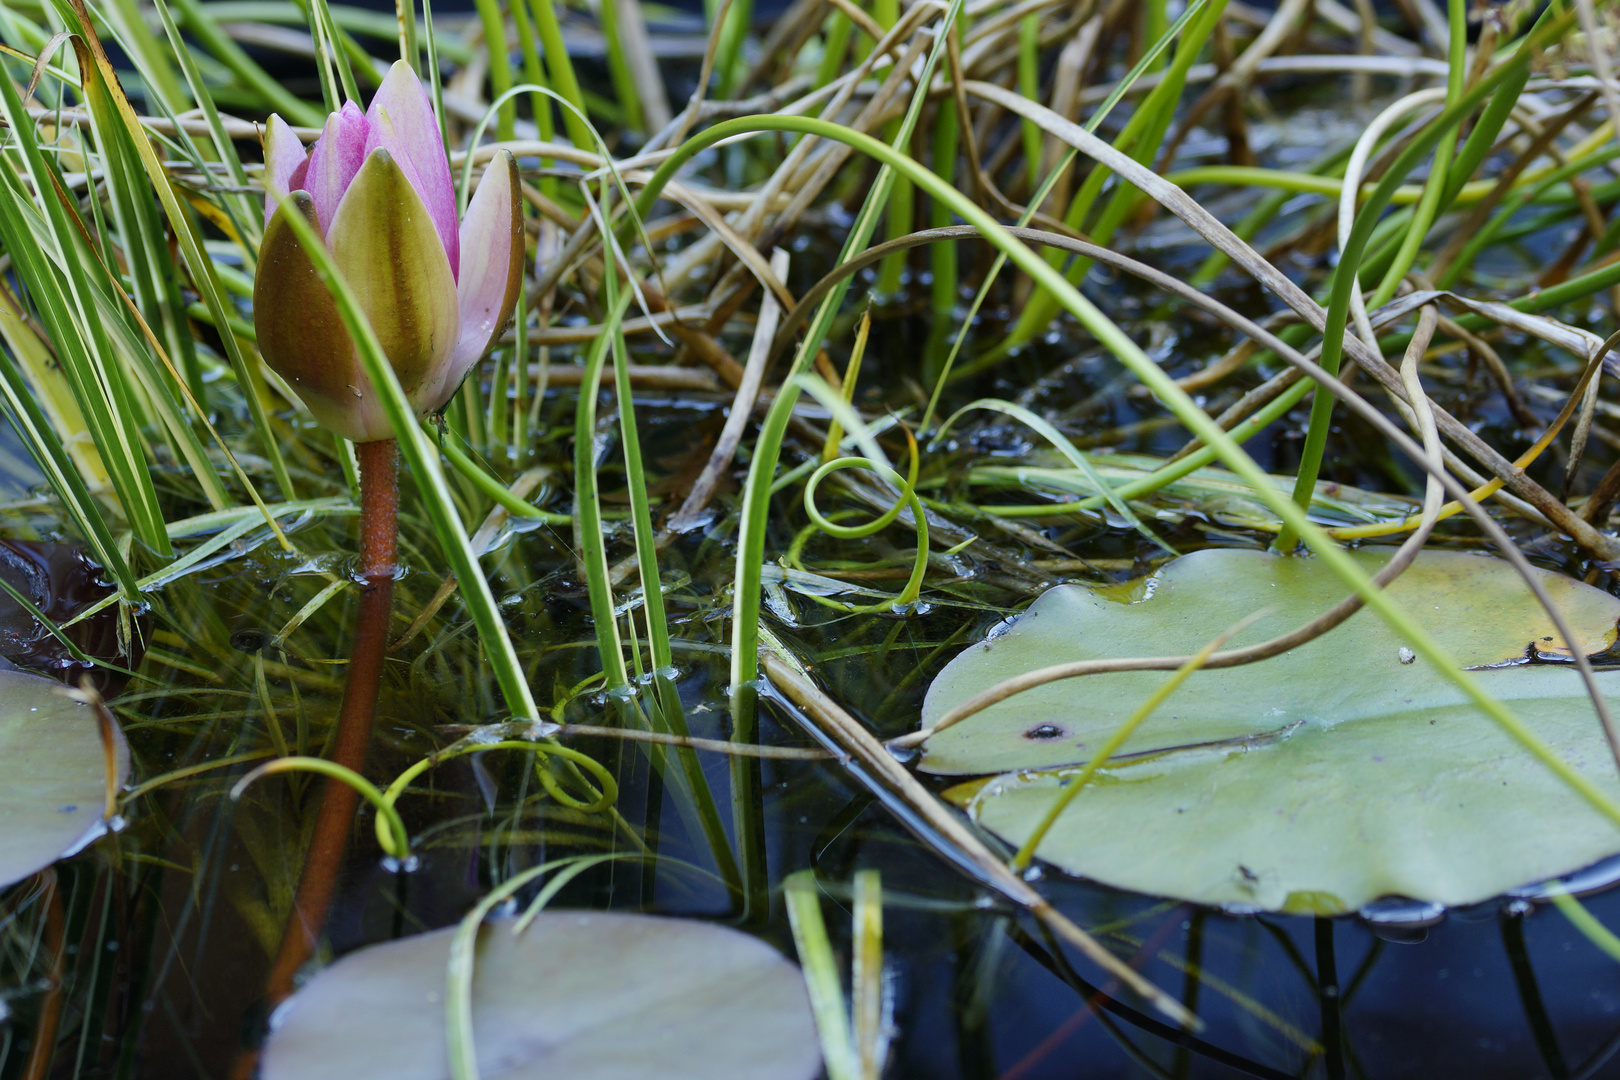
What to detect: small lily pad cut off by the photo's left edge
<box><xmin>0</xmin><ymin>670</ymin><xmax>130</xmax><ymax>887</ymax></box>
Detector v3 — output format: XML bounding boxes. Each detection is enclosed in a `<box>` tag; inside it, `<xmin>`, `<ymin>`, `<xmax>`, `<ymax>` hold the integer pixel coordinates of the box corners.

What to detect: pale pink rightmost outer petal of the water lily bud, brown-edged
<box><xmin>423</xmin><ymin>151</ymin><xmax>523</xmax><ymax>408</ymax></box>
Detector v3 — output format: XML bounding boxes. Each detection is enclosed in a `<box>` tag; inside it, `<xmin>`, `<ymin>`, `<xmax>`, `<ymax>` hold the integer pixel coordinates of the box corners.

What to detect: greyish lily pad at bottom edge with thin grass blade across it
<box><xmin>261</xmin><ymin>912</ymin><xmax>821</xmax><ymax>1080</ymax></box>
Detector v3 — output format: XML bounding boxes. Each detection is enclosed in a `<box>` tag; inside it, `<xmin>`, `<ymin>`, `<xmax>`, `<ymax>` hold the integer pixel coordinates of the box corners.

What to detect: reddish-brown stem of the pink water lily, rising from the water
<box><xmin>266</xmin><ymin>439</ymin><xmax>399</xmax><ymax>1009</ymax></box>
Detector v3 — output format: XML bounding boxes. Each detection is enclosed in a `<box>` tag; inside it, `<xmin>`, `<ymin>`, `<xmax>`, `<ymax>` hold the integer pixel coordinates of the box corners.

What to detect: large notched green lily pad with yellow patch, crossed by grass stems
<box><xmin>922</xmin><ymin>549</ymin><xmax>1620</xmax><ymax>913</ymax></box>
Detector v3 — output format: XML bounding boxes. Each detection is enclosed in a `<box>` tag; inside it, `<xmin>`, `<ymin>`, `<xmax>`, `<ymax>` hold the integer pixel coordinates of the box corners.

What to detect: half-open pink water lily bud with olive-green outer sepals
<box><xmin>253</xmin><ymin>62</ymin><xmax>523</xmax><ymax>442</ymax></box>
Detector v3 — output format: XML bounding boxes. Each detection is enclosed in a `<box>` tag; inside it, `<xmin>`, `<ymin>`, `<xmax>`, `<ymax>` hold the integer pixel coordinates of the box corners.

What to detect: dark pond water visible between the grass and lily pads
<box><xmin>0</xmin><ymin>69</ymin><xmax>1620</xmax><ymax>1080</ymax></box>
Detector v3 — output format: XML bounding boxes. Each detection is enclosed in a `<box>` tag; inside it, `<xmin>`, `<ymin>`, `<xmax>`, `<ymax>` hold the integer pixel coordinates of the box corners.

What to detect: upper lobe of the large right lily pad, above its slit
<box><xmin>922</xmin><ymin>549</ymin><xmax>1620</xmax><ymax>776</ymax></box>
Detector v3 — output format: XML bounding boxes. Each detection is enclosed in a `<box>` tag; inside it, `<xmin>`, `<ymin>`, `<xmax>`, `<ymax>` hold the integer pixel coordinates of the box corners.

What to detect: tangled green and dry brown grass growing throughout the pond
<box><xmin>0</xmin><ymin>0</ymin><xmax>1620</xmax><ymax>1078</ymax></box>
